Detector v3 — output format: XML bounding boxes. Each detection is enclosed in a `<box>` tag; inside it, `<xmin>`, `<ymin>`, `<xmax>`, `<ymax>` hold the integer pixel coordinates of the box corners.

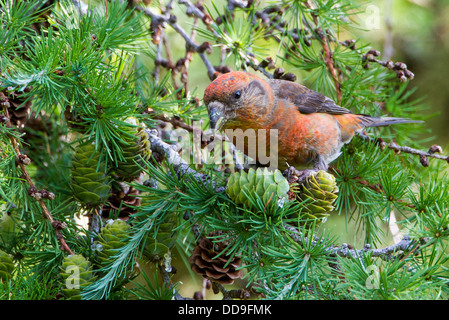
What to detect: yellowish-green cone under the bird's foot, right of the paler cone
<box><xmin>298</xmin><ymin>170</ymin><xmax>338</xmax><ymax>222</ymax></box>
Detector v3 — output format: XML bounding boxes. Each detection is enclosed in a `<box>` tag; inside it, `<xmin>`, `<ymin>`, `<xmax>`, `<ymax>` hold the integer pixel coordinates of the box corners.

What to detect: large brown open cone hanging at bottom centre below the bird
<box><xmin>189</xmin><ymin>237</ymin><xmax>243</xmax><ymax>284</ymax></box>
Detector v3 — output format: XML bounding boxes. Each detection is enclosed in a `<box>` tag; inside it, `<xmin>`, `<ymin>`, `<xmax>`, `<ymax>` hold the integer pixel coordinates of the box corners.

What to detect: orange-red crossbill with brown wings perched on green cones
<box><xmin>204</xmin><ymin>71</ymin><xmax>420</xmax><ymax>170</ymax></box>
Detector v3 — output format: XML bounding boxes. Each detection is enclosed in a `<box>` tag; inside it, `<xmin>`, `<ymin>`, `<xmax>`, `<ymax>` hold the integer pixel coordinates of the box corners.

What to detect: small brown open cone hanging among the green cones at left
<box><xmin>101</xmin><ymin>185</ymin><xmax>140</xmax><ymax>221</ymax></box>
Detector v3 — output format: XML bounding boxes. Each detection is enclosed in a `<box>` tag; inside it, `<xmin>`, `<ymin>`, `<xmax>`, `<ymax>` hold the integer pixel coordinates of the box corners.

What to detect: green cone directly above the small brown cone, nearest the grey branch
<box><xmin>115</xmin><ymin>118</ymin><xmax>151</xmax><ymax>181</ymax></box>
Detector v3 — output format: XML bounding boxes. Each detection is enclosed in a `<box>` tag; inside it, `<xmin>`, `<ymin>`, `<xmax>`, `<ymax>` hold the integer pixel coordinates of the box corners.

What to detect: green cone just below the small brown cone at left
<box><xmin>97</xmin><ymin>219</ymin><xmax>131</xmax><ymax>266</ymax></box>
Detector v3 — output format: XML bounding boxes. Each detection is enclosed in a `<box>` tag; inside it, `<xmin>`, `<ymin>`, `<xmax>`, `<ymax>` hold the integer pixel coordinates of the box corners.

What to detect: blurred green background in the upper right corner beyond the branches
<box><xmin>365</xmin><ymin>0</ymin><xmax>449</xmax><ymax>148</ymax></box>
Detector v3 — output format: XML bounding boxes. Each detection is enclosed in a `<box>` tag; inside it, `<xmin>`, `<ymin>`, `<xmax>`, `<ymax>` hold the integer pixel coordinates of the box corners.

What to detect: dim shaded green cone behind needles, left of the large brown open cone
<box><xmin>143</xmin><ymin>213</ymin><xmax>177</xmax><ymax>261</ymax></box>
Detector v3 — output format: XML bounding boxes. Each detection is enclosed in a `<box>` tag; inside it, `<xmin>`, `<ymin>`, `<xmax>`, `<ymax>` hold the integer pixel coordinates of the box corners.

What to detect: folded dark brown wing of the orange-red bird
<box><xmin>271</xmin><ymin>80</ymin><xmax>351</xmax><ymax>114</ymax></box>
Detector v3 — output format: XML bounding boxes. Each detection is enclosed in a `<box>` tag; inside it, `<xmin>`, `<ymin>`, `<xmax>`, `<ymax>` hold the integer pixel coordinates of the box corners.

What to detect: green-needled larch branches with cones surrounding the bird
<box><xmin>0</xmin><ymin>0</ymin><xmax>449</xmax><ymax>299</ymax></box>
